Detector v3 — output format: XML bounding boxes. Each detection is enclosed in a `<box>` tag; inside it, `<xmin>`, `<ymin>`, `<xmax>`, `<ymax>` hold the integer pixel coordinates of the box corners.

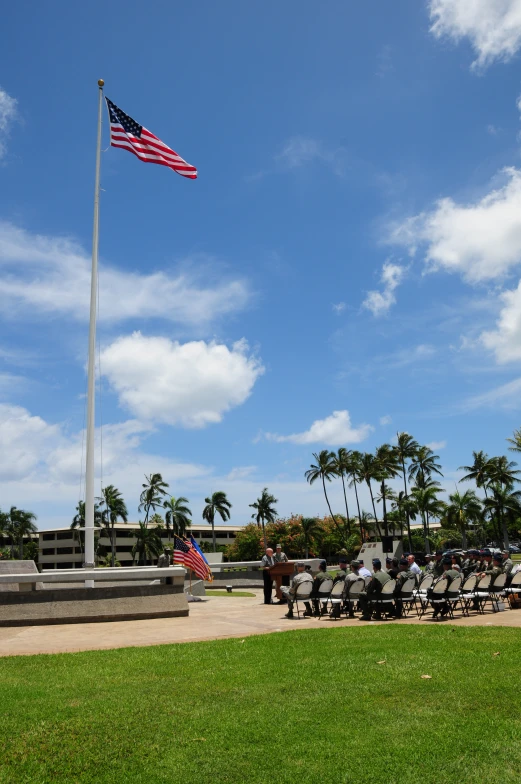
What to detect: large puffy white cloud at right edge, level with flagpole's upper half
<box><xmin>389</xmin><ymin>168</ymin><xmax>521</xmax><ymax>283</ymax></box>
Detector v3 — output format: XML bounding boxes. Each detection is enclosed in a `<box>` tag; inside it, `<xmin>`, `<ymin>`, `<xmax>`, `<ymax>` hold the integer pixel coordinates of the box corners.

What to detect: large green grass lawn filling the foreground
<box><xmin>0</xmin><ymin>620</ymin><xmax>521</xmax><ymax>784</ymax></box>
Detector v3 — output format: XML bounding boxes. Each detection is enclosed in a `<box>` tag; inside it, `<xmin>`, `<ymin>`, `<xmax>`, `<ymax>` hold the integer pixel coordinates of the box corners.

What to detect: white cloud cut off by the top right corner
<box><xmin>429</xmin><ymin>0</ymin><xmax>521</xmax><ymax>69</ymax></box>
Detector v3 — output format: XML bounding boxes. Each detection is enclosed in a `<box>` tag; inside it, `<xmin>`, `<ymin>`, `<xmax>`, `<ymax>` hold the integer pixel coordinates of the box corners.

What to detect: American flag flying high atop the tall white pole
<box><xmin>105</xmin><ymin>98</ymin><xmax>197</xmax><ymax>180</ymax></box>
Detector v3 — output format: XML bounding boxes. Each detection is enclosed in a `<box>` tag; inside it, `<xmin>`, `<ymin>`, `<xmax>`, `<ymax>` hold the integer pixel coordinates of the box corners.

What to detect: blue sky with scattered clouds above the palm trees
<box><xmin>0</xmin><ymin>0</ymin><xmax>521</xmax><ymax>527</ymax></box>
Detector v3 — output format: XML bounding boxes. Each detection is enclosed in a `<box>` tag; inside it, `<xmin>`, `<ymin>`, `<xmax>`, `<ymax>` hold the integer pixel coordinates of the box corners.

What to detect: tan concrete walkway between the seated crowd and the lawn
<box><xmin>0</xmin><ymin>591</ymin><xmax>521</xmax><ymax>656</ymax></box>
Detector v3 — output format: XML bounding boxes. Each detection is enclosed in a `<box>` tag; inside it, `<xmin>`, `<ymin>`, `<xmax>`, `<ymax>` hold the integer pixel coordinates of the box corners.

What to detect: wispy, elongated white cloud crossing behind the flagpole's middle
<box><xmin>0</xmin><ymin>222</ymin><xmax>249</xmax><ymax>325</ymax></box>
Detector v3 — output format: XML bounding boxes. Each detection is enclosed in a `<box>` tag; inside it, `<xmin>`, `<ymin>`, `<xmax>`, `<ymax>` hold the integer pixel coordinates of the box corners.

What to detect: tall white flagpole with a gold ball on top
<box><xmin>83</xmin><ymin>79</ymin><xmax>104</xmax><ymax>588</ymax></box>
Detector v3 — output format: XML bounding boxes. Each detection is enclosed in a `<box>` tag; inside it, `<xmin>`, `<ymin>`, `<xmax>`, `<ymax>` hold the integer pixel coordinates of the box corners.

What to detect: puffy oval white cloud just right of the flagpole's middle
<box><xmin>101</xmin><ymin>332</ymin><xmax>264</xmax><ymax>427</ymax></box>
